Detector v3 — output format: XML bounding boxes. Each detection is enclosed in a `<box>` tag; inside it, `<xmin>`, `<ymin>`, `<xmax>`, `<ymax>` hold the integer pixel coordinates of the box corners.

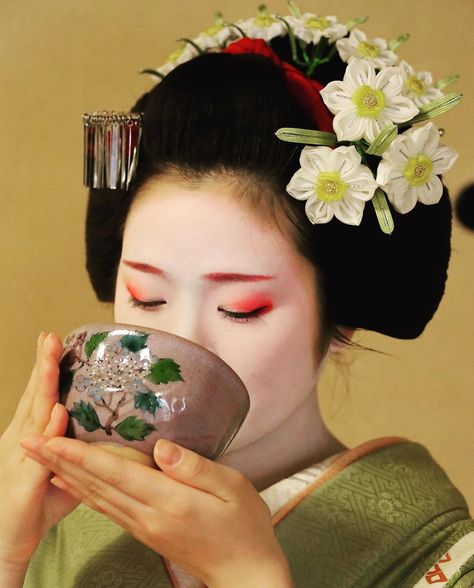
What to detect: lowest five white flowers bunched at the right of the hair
<box><xmin>287</xmin><ymin>35</ymin><xmax>458</xmax><ymax>225</ymax></box>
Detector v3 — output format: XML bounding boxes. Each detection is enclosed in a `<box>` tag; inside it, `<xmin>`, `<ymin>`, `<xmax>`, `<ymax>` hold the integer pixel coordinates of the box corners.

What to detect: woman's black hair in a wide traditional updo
<box><xmin>86</xmin><ymin>53</ymin><xmax>451</xmax><ymax>346</ymax></box>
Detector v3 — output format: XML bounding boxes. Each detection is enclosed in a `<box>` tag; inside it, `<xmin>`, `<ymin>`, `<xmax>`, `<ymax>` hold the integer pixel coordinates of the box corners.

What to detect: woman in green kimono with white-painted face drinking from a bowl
<box><xmin>0</xmin><ymin>10</ymin><xmax>474</xmax><ymax>588</ymax></box>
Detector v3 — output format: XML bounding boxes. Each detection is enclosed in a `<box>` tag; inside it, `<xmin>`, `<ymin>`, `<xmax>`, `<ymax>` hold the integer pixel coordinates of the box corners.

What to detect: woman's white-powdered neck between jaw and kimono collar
<box><xmin>217</xmin><ymin>393</ymin><xmax>346</xmax><ymax>491</ymax></box>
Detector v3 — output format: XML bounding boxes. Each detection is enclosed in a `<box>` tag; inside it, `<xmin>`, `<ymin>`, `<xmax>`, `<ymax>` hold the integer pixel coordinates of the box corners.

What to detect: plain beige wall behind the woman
<box><xmin>0</xmin><ymin>0</ymin><xmax>474</xmax><ymax>508</ymax></box>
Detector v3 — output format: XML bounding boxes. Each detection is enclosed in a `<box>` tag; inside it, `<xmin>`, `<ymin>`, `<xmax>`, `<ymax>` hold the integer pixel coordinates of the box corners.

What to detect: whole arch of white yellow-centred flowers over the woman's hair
<box><xmin>147</xmin><ymin>8</ymin><xmax>458</xmax><ymax>231</ymax></box>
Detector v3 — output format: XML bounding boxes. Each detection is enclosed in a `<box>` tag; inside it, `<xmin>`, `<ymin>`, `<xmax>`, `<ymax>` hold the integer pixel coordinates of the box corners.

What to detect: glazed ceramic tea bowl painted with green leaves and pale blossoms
<box><xmin>59</xmin><ymin>324</ymin><xmax>250</xmax><ymax>466</ymax></box>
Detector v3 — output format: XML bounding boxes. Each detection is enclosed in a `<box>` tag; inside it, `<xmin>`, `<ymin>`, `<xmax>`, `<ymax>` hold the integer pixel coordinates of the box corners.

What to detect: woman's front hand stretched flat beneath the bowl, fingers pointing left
<box><xmin>22</xmin><ymin>435</ymin><xmax>291</xmax><ymax>588</ymax></box>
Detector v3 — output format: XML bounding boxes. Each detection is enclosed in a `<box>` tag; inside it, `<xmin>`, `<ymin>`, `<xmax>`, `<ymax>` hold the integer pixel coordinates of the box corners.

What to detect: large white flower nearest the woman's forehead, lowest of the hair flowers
<box><xmin>286</xmin><ymin>145</ymin><xmax>377</xmax><ymax>225</ymax></box>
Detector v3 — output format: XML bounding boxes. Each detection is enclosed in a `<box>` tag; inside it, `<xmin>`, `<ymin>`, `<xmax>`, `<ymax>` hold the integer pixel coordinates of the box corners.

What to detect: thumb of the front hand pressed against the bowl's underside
<box><xmin>154</xmin><ymin>439</ymin><xmax>246</xmax><ymax>502</ymax></box>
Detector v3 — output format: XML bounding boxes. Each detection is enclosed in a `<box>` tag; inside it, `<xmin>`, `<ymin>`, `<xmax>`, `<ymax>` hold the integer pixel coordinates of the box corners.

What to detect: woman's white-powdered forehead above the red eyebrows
<box><xmin>123</xmin><ymin>179</ymin><xmax>312</xmax><ymax>276</ymax></box>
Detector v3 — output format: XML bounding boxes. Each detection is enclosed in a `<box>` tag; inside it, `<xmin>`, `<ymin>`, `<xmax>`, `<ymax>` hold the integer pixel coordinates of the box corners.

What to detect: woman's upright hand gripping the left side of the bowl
<box><xmin>0</xmin><ymin>333</ymin><xmax>78</xmax><ymax>568</ymax></box>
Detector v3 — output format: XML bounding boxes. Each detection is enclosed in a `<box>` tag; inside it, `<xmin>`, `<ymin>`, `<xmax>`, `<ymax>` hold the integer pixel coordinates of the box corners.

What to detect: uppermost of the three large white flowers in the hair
<box><xmin>321</xmin><ymin>59</ymin><xmax>419</xmax><ymax>143</ymax></box>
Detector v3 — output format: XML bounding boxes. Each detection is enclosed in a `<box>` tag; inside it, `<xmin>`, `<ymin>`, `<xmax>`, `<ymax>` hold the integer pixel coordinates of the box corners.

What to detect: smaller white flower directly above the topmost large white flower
<box><xmin>336</xmin><ymin>29</ymin><xmax>398</xmax><ymax>69</ymax></box>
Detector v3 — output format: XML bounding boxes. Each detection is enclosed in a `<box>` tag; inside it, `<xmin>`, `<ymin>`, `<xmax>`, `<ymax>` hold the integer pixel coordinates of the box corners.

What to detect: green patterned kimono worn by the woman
<box><xmin>24</xmin><ymin>438</ymin><xmax>474</xmax><ymax>588</ymax></box>
